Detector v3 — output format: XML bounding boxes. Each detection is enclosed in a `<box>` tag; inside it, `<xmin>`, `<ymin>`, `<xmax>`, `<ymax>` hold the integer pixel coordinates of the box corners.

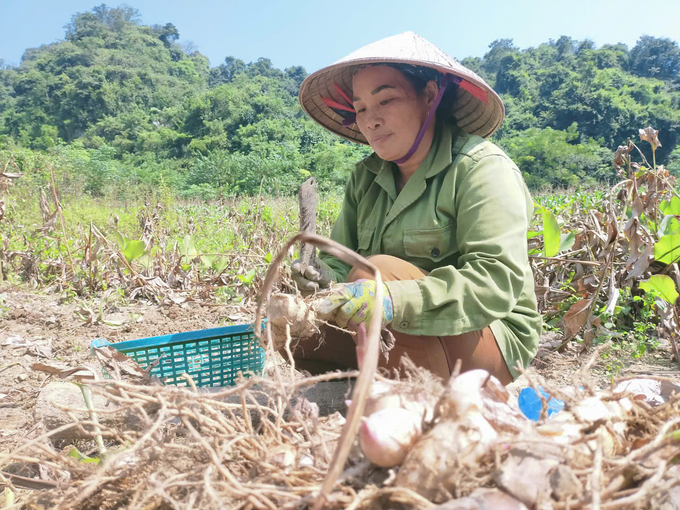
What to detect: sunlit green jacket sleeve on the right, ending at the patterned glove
<box><xmin>386</xmin><ymin>154</ymin><xmax>533</xmax><ymax>336</ymax></box>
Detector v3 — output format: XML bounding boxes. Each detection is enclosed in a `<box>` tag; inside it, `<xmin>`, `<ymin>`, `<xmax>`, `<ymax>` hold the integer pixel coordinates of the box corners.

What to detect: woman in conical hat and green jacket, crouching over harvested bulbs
<box><xmin>292</xmin><ymin>32</ymin><xmax>541</xmax><ymax>384</ymax></box>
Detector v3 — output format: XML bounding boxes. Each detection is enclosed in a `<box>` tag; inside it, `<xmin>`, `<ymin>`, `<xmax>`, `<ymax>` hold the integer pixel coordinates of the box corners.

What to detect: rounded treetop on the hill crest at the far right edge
<box><xmin>629</xmin><ymin>35</ymin><xmax>680</xmax><ymax>80</ymax></box>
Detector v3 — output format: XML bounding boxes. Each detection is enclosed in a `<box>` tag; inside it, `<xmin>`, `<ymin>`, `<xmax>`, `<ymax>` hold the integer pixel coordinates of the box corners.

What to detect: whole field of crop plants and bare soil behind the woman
<box><xmin>0</xmin><ymin>133</ymin><xmax>680</xmax><ymax>508</ymax></box>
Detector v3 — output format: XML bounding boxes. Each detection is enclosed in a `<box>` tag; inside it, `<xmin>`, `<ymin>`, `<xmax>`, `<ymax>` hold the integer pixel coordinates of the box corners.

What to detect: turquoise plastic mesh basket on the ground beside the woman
<box><xmin>91</xmin><ymin>324</ymin><xmax>264</xmax><ymax>386</ymax></box>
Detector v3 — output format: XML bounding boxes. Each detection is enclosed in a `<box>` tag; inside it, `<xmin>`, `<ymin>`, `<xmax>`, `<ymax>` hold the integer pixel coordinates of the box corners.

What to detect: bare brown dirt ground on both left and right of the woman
<box><xmin>0</xmin><ymin>287</ymin><xmax>678</xmax><ymax>460</ymax></box>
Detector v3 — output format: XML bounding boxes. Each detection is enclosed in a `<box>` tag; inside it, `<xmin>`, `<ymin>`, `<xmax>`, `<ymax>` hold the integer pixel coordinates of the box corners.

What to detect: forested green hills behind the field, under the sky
<box><xmin>0</xmin><ymin>5</ymin><xmax>680</xmax><ymax>198</ymax></box>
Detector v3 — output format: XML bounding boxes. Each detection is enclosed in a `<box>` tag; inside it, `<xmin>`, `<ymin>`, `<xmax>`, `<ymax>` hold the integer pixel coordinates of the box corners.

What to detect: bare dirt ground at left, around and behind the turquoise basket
<box><xmin>0</xmin><ymin>288</ymin><xmax>243</xmax><ymax>453</ymax></box>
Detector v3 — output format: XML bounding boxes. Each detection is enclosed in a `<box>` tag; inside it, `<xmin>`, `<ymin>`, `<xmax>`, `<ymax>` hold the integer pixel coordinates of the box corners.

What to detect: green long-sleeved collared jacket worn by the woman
<box><xmin>320</xmin><ymin>119</ymin><xmax>541</xmax><ymax>377</ymax></box>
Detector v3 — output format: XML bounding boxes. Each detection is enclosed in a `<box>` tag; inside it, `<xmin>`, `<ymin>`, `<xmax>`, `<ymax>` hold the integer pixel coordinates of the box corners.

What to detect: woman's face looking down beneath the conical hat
<box><xmin>352</xmin><ymin>66</ymin><xmax>437</xmax><ymax>161</ymax></box>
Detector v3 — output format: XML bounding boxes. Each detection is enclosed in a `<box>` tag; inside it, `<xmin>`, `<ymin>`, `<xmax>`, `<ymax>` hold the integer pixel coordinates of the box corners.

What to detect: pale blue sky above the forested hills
<box><xmin>0</xmin><ymin>0</ymin><xmax>680</xmax><ymax>72</ymax></box>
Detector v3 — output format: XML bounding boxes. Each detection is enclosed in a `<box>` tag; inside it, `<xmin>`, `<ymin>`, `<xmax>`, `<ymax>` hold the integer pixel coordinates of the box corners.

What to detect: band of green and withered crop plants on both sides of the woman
<box><xmin>0</xmin><ymin>126</ymin><xmax>680</xmax><ymax>380</ymax></box>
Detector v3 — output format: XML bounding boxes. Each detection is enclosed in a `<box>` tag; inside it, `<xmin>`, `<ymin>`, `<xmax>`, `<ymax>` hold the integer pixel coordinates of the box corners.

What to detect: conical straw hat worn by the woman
<box><xmin>300</xmin><ymin>32</ymin><xmax>505</xmax><ymax>144</ymax></box>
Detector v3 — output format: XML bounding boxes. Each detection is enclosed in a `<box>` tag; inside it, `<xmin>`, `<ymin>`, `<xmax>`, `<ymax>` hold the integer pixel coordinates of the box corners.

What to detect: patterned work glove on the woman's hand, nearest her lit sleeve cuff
<box><xmin>315</xmin><ymin>279</ymin><xmax>394</xmax><ymax>329</ymax></box>
